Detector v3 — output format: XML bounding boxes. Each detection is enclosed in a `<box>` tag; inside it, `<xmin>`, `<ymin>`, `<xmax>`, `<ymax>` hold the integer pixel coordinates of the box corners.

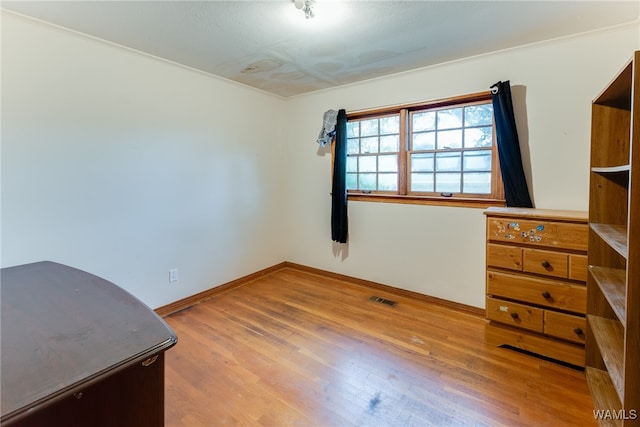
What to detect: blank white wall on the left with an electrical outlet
<box><xmin>2</xmin><ymin>12</ymin><xmax>285</xmax><ymax>307</ymax></box>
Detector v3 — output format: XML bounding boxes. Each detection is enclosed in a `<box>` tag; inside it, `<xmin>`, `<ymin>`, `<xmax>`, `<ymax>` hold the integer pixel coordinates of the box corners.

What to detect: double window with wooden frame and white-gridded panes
<box><xmin>346</xmin><ymin>92</ymin><xmax>504</xmax><ymax>206</ymax></box>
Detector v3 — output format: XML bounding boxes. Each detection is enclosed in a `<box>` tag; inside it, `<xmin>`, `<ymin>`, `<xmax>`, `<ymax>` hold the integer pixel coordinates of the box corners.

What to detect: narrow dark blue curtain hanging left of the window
<box><xmin>331</xmin><ymin>110</ymin><xmax>348</xmax><ymax>243</ymax></box>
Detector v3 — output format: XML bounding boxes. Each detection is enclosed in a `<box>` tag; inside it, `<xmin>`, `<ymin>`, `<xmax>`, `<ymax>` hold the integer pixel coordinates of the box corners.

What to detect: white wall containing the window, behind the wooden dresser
<box><xmin>286</xmin><ymin>24</ymin><xmax>640</xmax><ymax>307</ymax></box>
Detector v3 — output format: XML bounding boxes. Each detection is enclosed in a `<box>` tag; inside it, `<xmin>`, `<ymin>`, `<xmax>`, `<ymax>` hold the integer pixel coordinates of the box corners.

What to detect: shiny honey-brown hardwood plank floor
<box><xmin>165</xmin><ymin>268</ymin><xmax>596</xmax><ymax>427</ymax></box>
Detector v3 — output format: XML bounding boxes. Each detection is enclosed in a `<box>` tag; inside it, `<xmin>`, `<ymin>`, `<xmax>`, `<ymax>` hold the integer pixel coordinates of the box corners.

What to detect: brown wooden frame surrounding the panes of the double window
<box><xmin>340</xmin><ymin>91</ymin><xmax>505</xmax><ymax>208</ymax></box>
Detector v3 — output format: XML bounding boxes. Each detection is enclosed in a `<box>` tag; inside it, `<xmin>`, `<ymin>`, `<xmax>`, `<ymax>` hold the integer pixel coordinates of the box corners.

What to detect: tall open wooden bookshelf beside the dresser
<box><xmin>585</xmin><ymin>52</ymin><xmax>640</xmax><ymax>427</ymax></box>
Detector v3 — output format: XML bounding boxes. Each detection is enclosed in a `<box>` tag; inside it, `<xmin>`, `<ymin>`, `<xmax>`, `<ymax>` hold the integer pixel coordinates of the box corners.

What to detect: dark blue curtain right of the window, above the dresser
<box><xmin>491</xmin><ymin>81</ymin><xmax>533</xmax><ymax>208</ymax></box>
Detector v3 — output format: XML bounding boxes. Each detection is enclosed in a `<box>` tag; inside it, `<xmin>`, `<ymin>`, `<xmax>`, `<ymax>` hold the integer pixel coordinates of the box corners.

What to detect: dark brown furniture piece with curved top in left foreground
<box><xmin>0</xmin><ymin>262</ymin><xmax>177</xmax><ymax>427</ymax></box>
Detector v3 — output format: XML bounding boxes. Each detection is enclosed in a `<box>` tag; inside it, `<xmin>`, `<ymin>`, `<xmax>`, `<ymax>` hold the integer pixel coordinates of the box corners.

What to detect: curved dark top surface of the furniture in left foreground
<box><xmin>0</xmin><ymin>261</ymin><xmax>177</xmax><ymax>423</ymax></box>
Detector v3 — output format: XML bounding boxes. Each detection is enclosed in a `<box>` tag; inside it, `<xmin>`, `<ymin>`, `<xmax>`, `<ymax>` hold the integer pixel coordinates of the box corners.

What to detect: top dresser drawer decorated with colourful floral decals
<box><xmin>487</xmin><ymin>218</ymin><xmax>589</xmax><ymax>251</ymax></box>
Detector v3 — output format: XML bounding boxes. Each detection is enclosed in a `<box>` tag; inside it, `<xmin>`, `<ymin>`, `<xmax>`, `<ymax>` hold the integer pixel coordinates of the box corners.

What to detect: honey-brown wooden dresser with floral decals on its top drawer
<box><xmin>484</xmin><ymin>208</ymin><xmax>588</xmax><ymax>367</ymax></box>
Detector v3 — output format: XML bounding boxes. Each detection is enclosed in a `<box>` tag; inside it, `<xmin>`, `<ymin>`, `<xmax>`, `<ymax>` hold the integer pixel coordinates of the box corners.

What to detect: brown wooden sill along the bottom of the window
<box><xmin>347</xmin><ymin>193</ymin><xmax>505</xmax><ymax>209</ymax></box>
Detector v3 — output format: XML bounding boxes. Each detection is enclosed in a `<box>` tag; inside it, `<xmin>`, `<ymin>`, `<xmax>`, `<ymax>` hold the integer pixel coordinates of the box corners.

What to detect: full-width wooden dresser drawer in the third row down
<box><xmin>487</xmin><ymin>271</ymin><xmax>587</xmax><ymax>313</ymax></box>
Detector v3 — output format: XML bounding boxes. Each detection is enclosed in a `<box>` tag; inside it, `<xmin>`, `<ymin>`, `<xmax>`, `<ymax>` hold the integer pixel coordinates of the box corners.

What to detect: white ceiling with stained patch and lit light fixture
<box><xmin>2</xmin><ymin>0</ymin><xmax>640</xmax><ymax>97</ymax></box>
